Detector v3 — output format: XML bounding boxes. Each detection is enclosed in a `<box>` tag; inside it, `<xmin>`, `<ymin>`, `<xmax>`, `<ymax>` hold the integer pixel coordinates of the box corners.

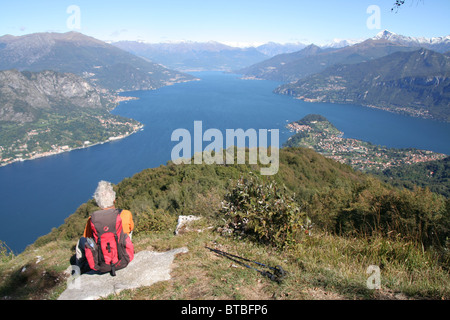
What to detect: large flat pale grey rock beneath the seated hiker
<box><xmin>58</xmin><ymin>248</ymin><xmax>188</xmax><ymax>300</ymax></box>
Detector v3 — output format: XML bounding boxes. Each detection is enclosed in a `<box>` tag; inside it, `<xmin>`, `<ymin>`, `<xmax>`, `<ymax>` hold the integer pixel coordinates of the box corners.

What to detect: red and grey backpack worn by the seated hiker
<box><xmin>85</xmin><ymin>209</ymin><xmax>134</xmax><ymax>276</ymax></box>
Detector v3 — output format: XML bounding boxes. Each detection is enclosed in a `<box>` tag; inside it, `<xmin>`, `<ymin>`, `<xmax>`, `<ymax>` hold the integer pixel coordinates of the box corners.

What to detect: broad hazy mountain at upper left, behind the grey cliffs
<box><xmin>0</xmin><ymin>32</ymin><xmax>194</xmax><ymax>91</ymax></box>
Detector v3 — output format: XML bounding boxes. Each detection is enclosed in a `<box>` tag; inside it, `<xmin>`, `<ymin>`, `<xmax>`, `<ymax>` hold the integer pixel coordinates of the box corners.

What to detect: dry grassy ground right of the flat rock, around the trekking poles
<box><xmin>102</xmin><ymin>220</ymin><xmax>450</xmax><ymax>300</ymax></box>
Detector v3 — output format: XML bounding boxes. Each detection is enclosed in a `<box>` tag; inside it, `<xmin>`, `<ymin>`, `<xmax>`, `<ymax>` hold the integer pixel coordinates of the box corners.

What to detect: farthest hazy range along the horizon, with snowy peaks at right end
<box><xmin>111</xmin><ymin>30</ymin><xmax>450</xmax><ymax>73</ymax></box>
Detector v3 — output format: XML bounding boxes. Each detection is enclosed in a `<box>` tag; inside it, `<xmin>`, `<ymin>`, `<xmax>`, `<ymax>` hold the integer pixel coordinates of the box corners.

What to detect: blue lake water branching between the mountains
<box><xmin>0</xmin><ymin>72</ymin><xmax>450</xmax><ymax>252</ymax></box>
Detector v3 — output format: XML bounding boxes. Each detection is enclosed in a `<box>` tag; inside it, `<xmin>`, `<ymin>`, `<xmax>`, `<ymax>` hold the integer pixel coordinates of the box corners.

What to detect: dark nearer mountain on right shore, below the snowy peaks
<box><xmin>275</xmin><ymin>48</ymin><xmax>450</xmax><ymax>121</ymax></box>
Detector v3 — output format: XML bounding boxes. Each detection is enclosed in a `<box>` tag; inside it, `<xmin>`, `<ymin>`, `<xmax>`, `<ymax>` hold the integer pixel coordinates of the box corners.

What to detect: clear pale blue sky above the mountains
<box><xmin>0</xmin><ymin>0</ymin><xmax>450</xmax><ymax>47</ymax></box>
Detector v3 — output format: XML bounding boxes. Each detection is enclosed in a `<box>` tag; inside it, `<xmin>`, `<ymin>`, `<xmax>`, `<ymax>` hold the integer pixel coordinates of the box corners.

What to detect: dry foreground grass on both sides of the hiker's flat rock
<box><xmin>0</xmin><ymin>215</ymin><xmax>450</xmax><ymax>300</ymax></box>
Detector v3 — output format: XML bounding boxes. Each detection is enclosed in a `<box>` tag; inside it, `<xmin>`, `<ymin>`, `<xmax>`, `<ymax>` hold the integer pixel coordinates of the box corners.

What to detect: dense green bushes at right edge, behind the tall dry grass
<box><xmin>307</xmin><ymin>178</ymin><xmax>450</xmax><ymax>247</ymax></box>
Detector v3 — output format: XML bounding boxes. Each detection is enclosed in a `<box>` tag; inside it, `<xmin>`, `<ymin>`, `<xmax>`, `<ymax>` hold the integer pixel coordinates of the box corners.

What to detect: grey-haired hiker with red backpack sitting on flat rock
<box><xmin>76</xmin><ymin>181</ymin><xmax>134</xmax><ymax>276</ymax></box>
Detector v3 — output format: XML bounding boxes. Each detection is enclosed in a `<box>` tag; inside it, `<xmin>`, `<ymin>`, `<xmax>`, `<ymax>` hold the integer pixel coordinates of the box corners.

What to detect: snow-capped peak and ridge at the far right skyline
<box><xmin>373</xmin><ymin>30</ymin><xmax>450</xmax><ymax>53</ymax></box>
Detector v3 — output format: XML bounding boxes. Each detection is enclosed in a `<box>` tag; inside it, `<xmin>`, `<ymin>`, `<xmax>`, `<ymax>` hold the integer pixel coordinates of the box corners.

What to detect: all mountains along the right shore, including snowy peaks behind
<box><xmin>235</xmin><ymin>30</ymin><xmax>450</xmax><ymax>121</ymax></box>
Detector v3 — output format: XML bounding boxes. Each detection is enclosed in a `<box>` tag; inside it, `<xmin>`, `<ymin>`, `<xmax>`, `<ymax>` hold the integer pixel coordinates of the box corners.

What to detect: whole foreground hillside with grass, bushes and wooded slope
<box><xmin>0</xmin><ymin>148</ymin><xmax>450</xmax><ymax>299</ymax></box>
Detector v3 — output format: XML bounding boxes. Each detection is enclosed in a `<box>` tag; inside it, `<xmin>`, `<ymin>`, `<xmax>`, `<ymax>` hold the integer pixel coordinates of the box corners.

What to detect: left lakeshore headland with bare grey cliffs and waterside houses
<box><xmin>0</xmin><ymin>70</ymin><xmax>143</xmax><ymax>166</ymax></box>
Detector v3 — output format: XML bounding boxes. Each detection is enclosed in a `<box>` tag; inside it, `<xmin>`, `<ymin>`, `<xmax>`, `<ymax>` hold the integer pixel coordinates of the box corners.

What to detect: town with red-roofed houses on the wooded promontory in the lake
<box><xmin>286</xmin><ymin>117</ymin><xmax>447</xmax><ymax>172</ymax></box>
